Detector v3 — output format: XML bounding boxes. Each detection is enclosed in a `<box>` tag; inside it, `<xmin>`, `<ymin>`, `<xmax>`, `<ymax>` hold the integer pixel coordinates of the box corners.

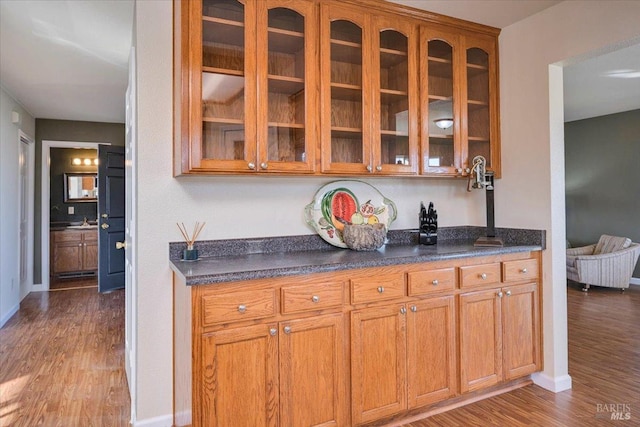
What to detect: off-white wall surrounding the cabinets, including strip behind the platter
<box><xmin>134</xmin><ymin>1</ymin><xmax>640</xmax><ymax>425</ymax></box>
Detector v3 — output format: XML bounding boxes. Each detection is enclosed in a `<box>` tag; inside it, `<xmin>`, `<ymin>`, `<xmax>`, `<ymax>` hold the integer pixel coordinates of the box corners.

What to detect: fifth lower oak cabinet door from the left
<box><xmin>459</xmin><ymin>289</ymin><xmax>502</xmax><ymax>393</ymax></box>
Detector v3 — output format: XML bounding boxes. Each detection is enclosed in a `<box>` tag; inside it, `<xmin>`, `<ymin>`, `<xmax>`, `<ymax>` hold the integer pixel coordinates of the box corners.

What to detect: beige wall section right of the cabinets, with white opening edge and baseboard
<box><xmin>496</xmin><ymin>1</ymin><xmax>640</xmax><ymax>390</ymax></box>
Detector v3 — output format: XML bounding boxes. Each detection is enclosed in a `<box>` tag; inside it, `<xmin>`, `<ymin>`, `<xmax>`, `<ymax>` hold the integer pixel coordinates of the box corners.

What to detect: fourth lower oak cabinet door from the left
<box><xmin>407</xmin><ymin>295</ymin><xmax>457</xmax><ymax>409</ymax></box>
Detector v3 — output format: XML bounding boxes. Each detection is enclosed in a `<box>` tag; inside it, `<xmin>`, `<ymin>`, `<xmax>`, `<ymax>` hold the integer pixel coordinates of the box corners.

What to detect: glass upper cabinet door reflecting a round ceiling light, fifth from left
<box><xmin>421</xmin><ymin>28</ymin><xmax>461</xmax><ymax>175</ymax></box>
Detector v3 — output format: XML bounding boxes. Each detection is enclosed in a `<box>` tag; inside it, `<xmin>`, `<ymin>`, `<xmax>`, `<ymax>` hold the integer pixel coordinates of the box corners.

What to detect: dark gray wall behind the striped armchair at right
<box><xmin>564</xmin><ymin>110</ymin><xmax>640</xmax><ymax>278</ymax></box>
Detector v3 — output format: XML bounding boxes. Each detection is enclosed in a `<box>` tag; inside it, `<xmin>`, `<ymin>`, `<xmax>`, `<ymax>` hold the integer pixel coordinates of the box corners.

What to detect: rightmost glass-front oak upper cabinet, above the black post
<box><xmin>463</xmin><ymin>38</ymin><xmax>500</xmax><ymax>175</ymax></box>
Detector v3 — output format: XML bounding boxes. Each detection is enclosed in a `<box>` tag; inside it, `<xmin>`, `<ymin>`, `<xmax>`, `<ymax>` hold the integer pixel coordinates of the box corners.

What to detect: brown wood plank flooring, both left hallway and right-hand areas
<box><xmin>0</xmin><ymin>284</ymin><xmax>640</xmax><ymax>427</ymax></box>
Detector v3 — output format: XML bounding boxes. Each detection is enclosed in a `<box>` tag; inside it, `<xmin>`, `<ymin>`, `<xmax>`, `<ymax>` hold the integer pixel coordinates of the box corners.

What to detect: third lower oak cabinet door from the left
<box><xmin>351</xmin><ymin>304</ymin><xmax>407</xmax><ymax>424</ymax></box>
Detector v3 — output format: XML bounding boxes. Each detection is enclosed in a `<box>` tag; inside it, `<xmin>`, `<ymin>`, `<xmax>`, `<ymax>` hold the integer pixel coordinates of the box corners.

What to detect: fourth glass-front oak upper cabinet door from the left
<box><xmin>372</xmin><ymin>17</ymin><xmax>419</xmax><ymax>174</ymax></box>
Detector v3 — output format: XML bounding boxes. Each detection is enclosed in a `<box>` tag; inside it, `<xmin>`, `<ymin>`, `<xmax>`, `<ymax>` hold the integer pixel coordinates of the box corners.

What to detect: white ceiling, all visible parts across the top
<box><xmin>0</xmin><ymin>0</ymin><xmax>640</xmax><ymax>123</ymax></box>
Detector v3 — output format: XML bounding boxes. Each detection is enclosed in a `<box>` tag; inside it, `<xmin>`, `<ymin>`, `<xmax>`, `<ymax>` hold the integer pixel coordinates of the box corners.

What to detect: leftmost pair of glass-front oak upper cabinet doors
<box><xmin>176</xmin><ymin>0</ymin><xmax>318</xmax><ymax>173</ymax></box>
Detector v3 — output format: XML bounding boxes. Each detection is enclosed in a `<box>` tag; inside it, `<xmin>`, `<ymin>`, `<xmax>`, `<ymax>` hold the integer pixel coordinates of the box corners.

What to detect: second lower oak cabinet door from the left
<box><xmin>279</xmin><ymin>313</ymin><xmax>348</xmax><ymax>427</ymax></box>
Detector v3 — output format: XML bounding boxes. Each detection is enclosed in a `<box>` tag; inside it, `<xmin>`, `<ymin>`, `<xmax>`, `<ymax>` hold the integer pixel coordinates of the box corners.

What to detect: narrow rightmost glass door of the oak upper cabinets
<box><xmin>464</xmin><ymin>37</ymin><xmax>496</xmax><ymax>173</ymax></box>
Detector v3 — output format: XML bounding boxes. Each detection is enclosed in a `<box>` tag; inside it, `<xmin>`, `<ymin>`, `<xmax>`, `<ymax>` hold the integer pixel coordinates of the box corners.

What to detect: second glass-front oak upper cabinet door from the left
<box><xmin>257</xmin><ymin>0</ymin><xmax>317</xmax><ymax>172</ymax></box>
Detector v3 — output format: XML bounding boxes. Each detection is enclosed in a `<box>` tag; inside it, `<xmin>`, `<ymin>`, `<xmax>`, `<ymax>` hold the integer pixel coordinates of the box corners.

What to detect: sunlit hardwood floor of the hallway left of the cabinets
<box><xmin>0</xmin><ymin>287</ymin><xmax>130</xmax><ymax>427</ymax></box>
